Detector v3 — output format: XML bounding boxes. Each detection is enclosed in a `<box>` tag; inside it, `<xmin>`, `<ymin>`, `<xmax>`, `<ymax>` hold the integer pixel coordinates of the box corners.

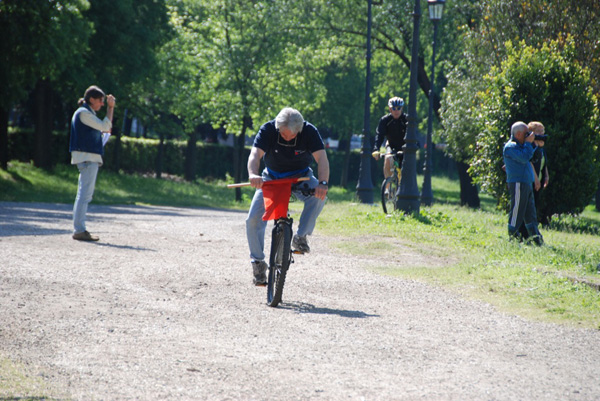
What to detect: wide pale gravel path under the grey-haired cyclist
<box><xmin>0</xmin><ymin>202</ymin><xmax>600</xmax><ymax>401</ymax></box>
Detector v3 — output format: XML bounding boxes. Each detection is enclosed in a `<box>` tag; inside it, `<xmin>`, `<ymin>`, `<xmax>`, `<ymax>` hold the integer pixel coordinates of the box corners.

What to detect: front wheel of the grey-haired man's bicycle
<box><xmin>267</xmin><ymin>224</ymin><xmax>292</xmax><ymax>307</ymax></box>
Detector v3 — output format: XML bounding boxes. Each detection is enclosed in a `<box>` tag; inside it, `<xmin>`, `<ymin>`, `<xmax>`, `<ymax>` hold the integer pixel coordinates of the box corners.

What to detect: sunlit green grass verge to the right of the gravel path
<box><xmin>318</xmin><ymin>191</ymin><xmax>600</xmax><ymax>329</ymax></box>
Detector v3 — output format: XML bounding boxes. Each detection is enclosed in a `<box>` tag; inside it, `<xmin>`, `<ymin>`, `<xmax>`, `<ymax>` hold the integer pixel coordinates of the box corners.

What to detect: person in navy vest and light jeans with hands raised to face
<box><xmin>69</xmin><ymin>85</ymin><xmax>115</xmax><ymax>241</ymax></box>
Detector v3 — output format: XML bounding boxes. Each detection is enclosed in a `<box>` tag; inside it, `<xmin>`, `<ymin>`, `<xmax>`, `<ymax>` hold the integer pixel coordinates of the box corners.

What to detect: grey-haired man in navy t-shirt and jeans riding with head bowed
<box><xmin>246</xmin><ymin>107</ymin><xmax>329</xmax><ymax>285</ymax></box>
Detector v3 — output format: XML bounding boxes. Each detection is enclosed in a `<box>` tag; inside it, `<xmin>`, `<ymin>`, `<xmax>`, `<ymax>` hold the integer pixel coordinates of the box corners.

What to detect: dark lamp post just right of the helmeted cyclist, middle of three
<box><xmin>396</xmin><ymin>0</ymin><xmax>421</xmax><ymax>213</ymax></box>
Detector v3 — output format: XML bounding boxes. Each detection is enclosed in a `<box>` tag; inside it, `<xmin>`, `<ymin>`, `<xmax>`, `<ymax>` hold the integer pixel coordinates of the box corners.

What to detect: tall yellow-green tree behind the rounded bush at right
<box><xmin>442</xmin><ymin>0</ymin><xmax>600</xmax><ymax>206</ymax></box>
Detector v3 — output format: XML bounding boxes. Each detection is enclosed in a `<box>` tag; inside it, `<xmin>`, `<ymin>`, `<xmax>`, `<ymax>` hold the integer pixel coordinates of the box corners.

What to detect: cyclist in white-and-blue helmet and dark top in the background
<box><xmin>373</xmin><ymin>97</ymin><xmax>408</xmax><ymax>178</ymax></box>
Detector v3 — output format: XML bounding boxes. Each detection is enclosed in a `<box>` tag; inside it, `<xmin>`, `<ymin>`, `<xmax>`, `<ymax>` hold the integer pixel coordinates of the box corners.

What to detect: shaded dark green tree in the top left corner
<box><xmin>0</xmin><ymin>0</ymin><xmax>90</xmax><ymax>169</ymax></box>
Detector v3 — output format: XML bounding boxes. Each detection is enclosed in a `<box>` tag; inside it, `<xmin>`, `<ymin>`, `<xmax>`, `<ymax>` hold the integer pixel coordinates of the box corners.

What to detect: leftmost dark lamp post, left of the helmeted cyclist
<box><xmin>356</xmin><ymin>0</ymin><xmax>373</xmax><ymax>204</ymax></box>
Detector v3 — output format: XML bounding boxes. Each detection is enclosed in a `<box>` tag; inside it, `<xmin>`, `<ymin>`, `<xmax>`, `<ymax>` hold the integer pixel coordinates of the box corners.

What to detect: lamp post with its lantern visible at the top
<box><xmin>421</xmin><ymin>0</ymin><xmax>446</xmax><ymax>206</ymax></box>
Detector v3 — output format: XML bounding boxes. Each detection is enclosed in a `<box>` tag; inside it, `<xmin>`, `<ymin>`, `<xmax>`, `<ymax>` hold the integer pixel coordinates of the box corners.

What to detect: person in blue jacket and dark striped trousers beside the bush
<box><xmin>503</xmin><ymin>121</ymin><xmax>544</xmax><ymax>245</ymax></box>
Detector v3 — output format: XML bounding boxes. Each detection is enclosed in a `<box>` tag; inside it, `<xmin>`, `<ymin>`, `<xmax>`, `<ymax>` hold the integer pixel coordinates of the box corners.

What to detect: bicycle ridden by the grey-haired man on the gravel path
<box><xmin>228</xmin><ymin>177</ymin><xmax>315</xmax><ymax>307</ymax></box>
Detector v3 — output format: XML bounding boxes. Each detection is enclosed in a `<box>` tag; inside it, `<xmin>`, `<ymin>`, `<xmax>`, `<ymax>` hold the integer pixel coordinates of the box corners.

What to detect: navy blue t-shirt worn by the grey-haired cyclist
<box><xmin>253</xmin><ymin>120</ymin><xmax>325</xmax><ymax>178</ymax></box>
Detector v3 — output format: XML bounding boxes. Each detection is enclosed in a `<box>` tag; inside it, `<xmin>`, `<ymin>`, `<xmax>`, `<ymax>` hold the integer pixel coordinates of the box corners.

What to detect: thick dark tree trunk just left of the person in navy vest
<box><xmin>33</xmin><ymin>80</ymin><xmax>54</xmax><ymax>170</ymax></box>
